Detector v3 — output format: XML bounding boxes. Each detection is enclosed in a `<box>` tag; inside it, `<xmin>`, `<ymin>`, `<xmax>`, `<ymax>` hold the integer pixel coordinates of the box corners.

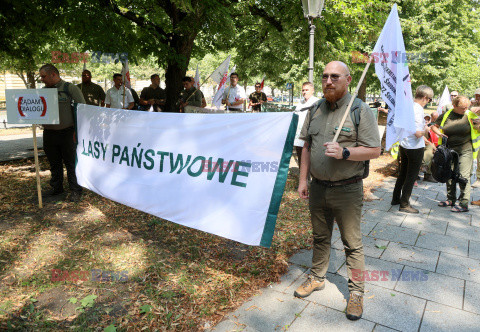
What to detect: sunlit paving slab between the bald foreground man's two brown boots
<box><xmin>286</xmin><ymin>273</ymin><xmax>350</xmax><ymax>311</ymax></box>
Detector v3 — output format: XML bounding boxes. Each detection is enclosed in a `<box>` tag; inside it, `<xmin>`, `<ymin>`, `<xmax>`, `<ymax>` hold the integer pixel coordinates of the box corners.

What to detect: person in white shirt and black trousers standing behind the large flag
<box><xmin>392</xmin><ymin>85</ymin><xmax>433</xmax><ymax>213</ymax></box>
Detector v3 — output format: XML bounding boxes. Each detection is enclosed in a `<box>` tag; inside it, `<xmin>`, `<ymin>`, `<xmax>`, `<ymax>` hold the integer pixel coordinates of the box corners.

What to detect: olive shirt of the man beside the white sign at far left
<box><xmin>43</xmin><ymin>80</ymin><xmax>85</xmax><ymax>130</ymax></box>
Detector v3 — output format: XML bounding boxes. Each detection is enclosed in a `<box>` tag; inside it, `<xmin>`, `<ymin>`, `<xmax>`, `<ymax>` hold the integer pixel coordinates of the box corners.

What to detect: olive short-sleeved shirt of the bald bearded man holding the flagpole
<box><xmin>300</xmin><ymin>93</ymin><xmax>380</xmax><ymax>181</ymax></box>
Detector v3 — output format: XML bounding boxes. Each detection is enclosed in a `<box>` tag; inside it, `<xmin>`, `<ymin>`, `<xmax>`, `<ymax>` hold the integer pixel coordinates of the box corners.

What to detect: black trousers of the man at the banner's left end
<box><xmin>43</xmin><ymin>127</ymin><xmax>82</xmax><ymax>192</ymax></box>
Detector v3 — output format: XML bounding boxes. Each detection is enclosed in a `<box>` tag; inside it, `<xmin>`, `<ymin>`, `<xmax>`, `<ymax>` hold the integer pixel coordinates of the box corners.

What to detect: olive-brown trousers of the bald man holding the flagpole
<box><xmin>310</xmin><ymin>179</ymin><xmax>365</xmax><ymax>293</ymax></box>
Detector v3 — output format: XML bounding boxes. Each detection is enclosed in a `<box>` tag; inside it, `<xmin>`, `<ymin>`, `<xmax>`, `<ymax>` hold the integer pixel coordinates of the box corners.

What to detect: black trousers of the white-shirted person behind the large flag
<box><xmin>392</xmin><ymin>146</ymin><xmax>425</xmax><ymax>207</ymax></box>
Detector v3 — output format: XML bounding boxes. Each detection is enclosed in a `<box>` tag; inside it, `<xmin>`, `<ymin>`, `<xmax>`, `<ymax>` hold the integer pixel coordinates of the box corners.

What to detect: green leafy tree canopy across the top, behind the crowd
<box><xmin>0</xmin><ymin>0</ymin><xmax>480</xmax><ymax>103</ymax></box>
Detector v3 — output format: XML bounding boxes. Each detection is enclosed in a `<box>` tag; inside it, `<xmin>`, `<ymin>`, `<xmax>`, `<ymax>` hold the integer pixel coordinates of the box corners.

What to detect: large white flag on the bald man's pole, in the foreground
<box><xmin>372</xmin><ymin>4</ymin><xmax>415</xmax><ymax>150</ymax></box>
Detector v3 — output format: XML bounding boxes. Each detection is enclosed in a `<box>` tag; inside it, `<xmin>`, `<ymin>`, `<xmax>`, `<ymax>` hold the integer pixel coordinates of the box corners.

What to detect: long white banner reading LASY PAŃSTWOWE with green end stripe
<box><xmin>76</xmin><ymin>104</ymin><xmax>298</xmax><ymax>247</ymax></box>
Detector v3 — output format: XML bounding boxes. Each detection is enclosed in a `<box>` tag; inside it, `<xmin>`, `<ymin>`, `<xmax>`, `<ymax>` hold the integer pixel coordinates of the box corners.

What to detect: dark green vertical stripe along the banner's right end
<box><xmin>260</xmin><ymin>114</ymin><xmax>298</xmax><ymax>248</ymax></box>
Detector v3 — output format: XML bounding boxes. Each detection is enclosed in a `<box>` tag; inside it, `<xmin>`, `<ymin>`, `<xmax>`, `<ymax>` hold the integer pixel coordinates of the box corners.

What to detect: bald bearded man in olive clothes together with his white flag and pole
<box><xmin>294</xmin><ymin>5</ymin><xmax>415</xmax><ymax>320</ymax></box>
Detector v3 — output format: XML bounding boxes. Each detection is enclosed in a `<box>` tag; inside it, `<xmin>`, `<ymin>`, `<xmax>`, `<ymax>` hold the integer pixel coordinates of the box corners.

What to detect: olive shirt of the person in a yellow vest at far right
<box><xmin>435</xmin><ymin>111</ymin><xmax>472</xmax><ymax>149</ymax></box>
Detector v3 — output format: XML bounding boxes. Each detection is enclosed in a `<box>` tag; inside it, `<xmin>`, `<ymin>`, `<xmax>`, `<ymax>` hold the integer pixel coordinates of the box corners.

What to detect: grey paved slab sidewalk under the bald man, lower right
<box><xmin>211</xmin><ymin>178</ymin><xmax>480</xmax><ymax>332</ymax></box>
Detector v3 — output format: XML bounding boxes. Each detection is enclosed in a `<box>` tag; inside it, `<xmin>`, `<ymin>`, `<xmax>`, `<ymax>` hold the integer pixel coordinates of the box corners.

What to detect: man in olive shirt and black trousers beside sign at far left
<box><xmin>40</xmin><ymin>64</ymin><xmax>85</xmax><ymax>202</ymax></box>
